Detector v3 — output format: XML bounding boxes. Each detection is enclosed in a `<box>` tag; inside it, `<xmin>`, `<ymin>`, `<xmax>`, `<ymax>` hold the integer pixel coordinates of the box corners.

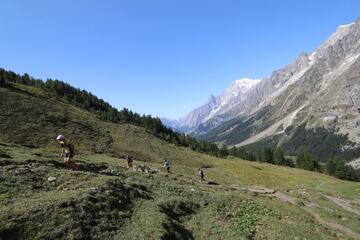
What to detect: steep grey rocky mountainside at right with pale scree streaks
<box><xmin>199</xmin><ymin>20</ymin><xmax>360</xmax><ymax>160</ymax></box>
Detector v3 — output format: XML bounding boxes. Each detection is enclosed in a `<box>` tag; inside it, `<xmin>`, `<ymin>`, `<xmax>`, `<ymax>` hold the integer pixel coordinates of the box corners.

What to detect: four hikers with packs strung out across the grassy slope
<box><xmin>56</xmin><ymin>135</ymin><xmax>205</xmax><ymax>183</ymax></box>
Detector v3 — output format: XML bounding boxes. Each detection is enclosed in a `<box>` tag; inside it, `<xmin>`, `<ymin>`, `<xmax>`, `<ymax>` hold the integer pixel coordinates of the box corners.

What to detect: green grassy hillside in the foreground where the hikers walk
<box><xmin>0</xmin><ymin>85</ymin><xmax>360</xmax><ymax>239</ymax></box>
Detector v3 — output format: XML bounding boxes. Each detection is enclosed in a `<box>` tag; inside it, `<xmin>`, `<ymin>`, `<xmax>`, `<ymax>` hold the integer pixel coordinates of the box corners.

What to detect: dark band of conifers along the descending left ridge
<box><xmin>0</xmin><ymin>68</ymin><xmax>226</xmax><ymax>157</ymax></box>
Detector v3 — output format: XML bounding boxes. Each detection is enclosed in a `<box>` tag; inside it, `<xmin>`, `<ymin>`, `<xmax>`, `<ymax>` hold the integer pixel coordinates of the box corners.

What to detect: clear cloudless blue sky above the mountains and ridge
<box><xmin>0</xmin><ymin>0</ymin><xmax>360</xmax><ymax>118</ymax></box>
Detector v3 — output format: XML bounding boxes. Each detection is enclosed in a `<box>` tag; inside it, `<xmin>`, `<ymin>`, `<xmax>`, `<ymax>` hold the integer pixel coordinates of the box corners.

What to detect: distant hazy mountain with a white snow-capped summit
<box><xmin>161</xmin><ymin>78</ymin><xmax>260</xmax><ymax>133</ymax></box>
